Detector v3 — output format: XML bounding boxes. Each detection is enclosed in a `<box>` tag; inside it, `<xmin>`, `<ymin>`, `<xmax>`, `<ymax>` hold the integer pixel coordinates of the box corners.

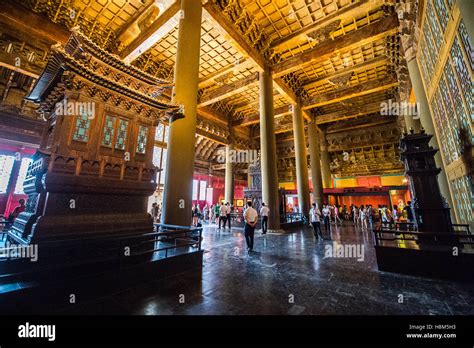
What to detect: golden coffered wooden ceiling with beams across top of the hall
<box><xmin>0</xmin><ymin>0</ymin><xmax>416</xmax><ymax>178</ymax></box>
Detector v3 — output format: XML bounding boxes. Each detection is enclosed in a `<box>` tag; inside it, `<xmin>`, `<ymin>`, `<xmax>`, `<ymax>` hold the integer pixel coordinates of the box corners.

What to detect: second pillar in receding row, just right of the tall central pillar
<box><xmin>292</xmin><ymin>104</ymin><xmax>310</xmax><ymax>216</ymax></box>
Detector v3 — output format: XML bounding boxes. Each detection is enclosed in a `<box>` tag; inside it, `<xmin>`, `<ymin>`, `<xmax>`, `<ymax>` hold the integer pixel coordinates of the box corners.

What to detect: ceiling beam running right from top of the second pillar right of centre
<box><xmin>301</xmin><ymin>77</ymin><xmax>398</xmax><ymax>110</ymax></box>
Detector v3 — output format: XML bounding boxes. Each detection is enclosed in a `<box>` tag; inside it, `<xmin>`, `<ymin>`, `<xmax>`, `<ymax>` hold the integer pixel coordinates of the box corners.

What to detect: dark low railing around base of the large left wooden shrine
<box><xmin>0</xmin><ymin>224</ymin><xmax>202</xmax><ymax>280</ymax></box>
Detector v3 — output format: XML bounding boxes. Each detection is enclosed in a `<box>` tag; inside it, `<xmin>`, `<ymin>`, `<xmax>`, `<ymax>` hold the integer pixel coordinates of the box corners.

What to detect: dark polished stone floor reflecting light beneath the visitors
<box><xmin>49</xmin><ymin>224</ymin><xmax>474</xmax><ymax>315</ymax></box>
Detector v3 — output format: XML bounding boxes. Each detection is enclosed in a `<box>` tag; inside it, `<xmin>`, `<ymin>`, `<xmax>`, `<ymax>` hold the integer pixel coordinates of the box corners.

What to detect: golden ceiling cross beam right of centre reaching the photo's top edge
<box><xmin>271</xmin><ymin>0</ymin><xmax>384</xmax><ymax>52</ymax></box>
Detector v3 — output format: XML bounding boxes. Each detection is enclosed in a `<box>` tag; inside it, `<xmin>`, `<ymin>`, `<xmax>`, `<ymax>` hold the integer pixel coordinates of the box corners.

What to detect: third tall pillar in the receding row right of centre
<box><xmin>308</xmin><ymin>122</ymin><xmax>324</xmax><ymax>209</ymax></box>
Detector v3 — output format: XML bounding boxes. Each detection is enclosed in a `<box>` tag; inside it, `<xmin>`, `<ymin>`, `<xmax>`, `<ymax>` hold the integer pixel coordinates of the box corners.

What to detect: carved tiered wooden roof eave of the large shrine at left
<box><xmin>27</xmin><ymin>29</ymin><xmax>182</xmax><ymax>119</ymax></box>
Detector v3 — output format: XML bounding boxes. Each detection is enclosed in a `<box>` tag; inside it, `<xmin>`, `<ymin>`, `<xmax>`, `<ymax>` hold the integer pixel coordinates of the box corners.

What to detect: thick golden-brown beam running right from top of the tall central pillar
<box><xmin>272</xmin><ymin>14</ymin><xmax>398</xmax><ymax>78</ymax></box>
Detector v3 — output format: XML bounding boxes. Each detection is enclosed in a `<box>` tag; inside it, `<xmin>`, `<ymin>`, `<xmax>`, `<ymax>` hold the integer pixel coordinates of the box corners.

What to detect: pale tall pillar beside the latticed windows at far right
<box><xmin>408</xmin><ymin>59</ymin><xmax>455</xmax><ymax>220</ymax></box>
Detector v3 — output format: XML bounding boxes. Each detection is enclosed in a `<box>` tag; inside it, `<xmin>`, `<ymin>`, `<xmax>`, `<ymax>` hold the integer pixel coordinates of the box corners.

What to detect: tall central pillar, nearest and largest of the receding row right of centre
<box><xmin>260</xmin><ymin>69</ymin><xmax>280</xmax><ymax>230</ymax></box>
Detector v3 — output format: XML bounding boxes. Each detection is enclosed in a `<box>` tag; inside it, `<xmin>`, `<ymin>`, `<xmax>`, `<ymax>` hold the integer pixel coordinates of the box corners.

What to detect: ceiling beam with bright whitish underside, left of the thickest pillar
<box><xmin>120</xmin><ymin>0</ymin><xmax>181</xmax><ymax>62</ymax></box>
